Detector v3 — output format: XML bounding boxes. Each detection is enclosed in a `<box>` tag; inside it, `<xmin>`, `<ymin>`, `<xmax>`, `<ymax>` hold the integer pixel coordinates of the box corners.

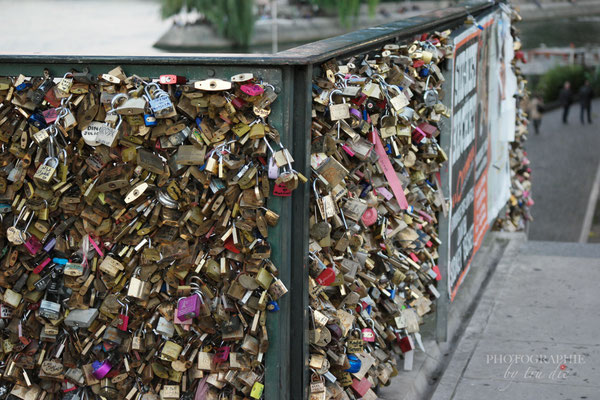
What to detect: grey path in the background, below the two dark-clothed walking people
<box><xmin>526</xmin><ymin>100</ymin><xmax>600</xmax><ymax>242</ymax></box>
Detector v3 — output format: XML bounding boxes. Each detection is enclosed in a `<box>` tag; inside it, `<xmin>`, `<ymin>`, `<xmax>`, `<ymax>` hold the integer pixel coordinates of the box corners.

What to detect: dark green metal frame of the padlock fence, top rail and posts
<box><xmin>0</xmin><ymin>2</ymin><xmax>497</xmax><ymax>400</ymax></box>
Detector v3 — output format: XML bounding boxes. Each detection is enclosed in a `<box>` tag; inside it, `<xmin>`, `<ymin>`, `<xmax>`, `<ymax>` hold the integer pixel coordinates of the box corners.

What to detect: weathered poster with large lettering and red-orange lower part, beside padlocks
<box><xmin>448</xmin><ymin>15</ymin><xmax>497</xmax><ymax>299</ymax></box>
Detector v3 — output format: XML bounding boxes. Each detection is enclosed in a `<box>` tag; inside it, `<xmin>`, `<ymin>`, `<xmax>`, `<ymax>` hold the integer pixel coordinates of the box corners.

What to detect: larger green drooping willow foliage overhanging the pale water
<box><xmin>162</xmin><ymin>0</ymin><xmax>255</xmax><ymax>47</ymax></box>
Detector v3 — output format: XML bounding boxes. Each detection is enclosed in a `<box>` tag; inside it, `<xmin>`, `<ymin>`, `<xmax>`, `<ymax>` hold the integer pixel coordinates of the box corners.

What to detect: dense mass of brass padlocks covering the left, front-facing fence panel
<box><xmin>0</xmin><ymin>67</ymin><xmax>302</xmax><ymax>400</ymax></box>
